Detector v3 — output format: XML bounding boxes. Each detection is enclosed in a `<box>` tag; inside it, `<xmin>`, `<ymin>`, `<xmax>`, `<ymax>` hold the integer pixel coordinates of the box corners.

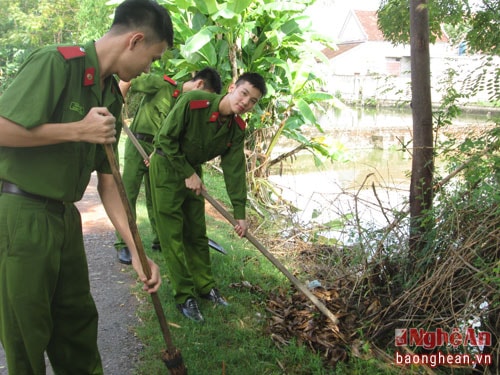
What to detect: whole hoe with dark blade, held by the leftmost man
<box><xmin>104</xmin><ymin>144</ymin><xmax>187</xmax><ymax>375</ymax></box>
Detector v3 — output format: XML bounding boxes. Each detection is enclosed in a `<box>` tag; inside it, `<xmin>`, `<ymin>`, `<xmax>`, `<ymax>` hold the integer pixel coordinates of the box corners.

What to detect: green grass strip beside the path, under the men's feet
<box><xmin>115</xmin><ymin>142</ymin><xmax>396</xmax><ymax>375</ymax></box>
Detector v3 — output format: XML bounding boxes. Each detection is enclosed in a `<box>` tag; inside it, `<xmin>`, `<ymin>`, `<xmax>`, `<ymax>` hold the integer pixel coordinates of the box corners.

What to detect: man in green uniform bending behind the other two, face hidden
<box><xmin>115</xmin><ymin>68</ymin><xmax>222</xmax><ymax>264</ymax></box>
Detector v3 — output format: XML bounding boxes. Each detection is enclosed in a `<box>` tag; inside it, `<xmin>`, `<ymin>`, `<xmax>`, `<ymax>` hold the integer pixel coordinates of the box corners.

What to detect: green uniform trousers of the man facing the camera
<box><xmin>150</xmin><ymin>154</ymin><xmax>215</xmax><ymax>304</ymax></box>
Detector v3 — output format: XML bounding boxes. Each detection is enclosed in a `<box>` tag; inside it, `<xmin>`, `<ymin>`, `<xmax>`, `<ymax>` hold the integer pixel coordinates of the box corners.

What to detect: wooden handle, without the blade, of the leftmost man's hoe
<box><xmin>104</xmin><ymin>144</ymin><xmax>177</xmax><ymax>353</ymax></box>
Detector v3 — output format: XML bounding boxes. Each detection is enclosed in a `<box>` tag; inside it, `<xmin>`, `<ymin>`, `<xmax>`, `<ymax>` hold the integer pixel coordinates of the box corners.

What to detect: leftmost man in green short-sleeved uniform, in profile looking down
<box><xmin>0</xmin><ymin>0</ymin><xmax>173</xmax><ymax>375</ymax></box>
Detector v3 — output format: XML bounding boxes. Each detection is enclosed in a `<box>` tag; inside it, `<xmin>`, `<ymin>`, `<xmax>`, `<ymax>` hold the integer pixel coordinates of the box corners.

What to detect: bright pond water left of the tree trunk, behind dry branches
<box><xmin>269</xmin><ymin>109</ymin><xmax>490</xmax><ymax>235</ymax></box>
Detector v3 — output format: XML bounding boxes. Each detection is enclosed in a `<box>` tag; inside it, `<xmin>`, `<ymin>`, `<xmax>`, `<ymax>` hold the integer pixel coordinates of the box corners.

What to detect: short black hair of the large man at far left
<box><xmin>111</xmin><ymin>0</ymin><xmax>174</xmax><ymax>47</ymax></box>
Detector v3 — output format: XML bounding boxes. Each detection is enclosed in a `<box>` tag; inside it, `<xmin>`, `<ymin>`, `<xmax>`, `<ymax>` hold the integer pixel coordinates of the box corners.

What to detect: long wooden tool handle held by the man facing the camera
<box><xmin>202</xmin><ymin>190</ymin><xmax>339</xmax><ymax>324</ymax></box>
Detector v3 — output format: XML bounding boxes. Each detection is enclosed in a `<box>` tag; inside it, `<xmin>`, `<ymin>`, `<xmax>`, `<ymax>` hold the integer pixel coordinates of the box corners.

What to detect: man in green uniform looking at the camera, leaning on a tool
<box><xmin>150</xmin><ymin>73</ymin><xmax>267</xmax><ymax>322</ymax></box>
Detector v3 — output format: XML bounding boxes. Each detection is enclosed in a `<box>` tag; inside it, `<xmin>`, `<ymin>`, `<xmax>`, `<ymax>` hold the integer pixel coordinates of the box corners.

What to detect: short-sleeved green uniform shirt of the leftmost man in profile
<box><xmin>0</xmin><ymin>42</ymin><xmax>123</xmax><ymax>202</ymax></box>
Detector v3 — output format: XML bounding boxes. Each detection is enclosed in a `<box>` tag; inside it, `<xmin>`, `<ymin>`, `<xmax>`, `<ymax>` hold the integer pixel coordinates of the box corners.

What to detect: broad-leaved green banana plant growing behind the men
<box><xmin>159</xmin><ymin>0</ymin><xmax>340</xmax><ymax>203</ymax></box>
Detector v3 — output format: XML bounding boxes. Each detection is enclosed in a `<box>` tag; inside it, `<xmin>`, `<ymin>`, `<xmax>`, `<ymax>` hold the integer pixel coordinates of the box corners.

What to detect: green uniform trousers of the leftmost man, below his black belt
<box><xmin>0</xmin><ymin>193</ymin><xmax>103</xmax><ymax>375</ymax></box>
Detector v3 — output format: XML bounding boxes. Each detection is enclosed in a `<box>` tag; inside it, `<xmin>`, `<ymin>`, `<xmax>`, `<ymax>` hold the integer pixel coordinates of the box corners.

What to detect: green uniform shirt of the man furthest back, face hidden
<box><xmin>130</xmin><ymin>74</ymin><xmax>182</xmax><ymax>135</ymax></box>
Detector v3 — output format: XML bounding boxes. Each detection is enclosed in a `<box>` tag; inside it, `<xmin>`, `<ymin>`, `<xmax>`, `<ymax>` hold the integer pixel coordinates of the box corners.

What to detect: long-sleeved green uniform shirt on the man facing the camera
<box><xmin>155</xmin><ymin>91</ymin><xmax>247</xmax><ymax>219</ymax></box>
